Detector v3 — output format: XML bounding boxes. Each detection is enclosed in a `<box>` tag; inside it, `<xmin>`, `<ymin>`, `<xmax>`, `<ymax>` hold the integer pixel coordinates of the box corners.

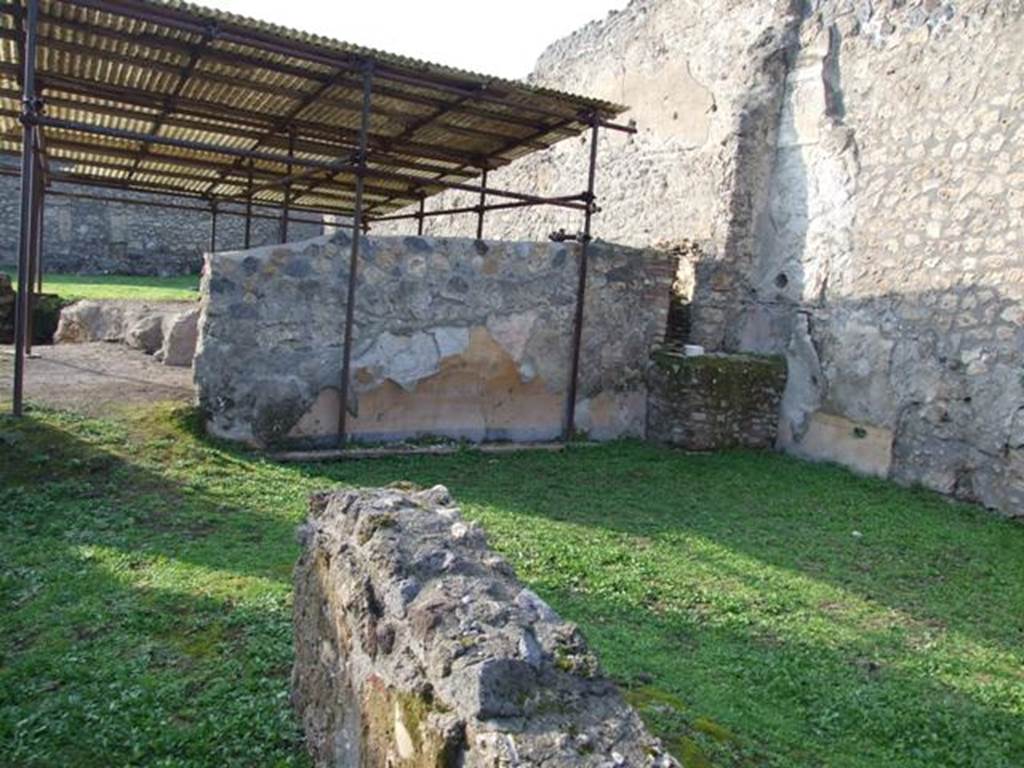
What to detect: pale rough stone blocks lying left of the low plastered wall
<box><xmin>53</xmin><ymin>301</ymin><xmax>199</xmax><ymax>368</ymax></box>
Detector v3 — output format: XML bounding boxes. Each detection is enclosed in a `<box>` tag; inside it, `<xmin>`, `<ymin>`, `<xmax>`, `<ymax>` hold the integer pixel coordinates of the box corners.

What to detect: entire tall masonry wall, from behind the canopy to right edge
<box><xmin>380</xmin><ymin>0</ymin><xmax>1024</xmax><ymax>514</ymax></box>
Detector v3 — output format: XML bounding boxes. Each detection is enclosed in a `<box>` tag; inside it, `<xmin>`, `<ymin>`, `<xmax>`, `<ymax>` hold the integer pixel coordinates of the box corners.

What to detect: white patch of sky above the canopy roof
<box><xmin>196</xmin><ymin>0</ymin><xmax>629</xmax><ymax>79</ymax></box>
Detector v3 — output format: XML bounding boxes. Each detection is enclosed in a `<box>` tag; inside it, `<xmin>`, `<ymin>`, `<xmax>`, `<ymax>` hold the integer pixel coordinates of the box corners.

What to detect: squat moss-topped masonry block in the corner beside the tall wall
<box><xmin>647</xmin><ymin>351</ymin><xmax>785</xmax><ymax>451</ymax></box>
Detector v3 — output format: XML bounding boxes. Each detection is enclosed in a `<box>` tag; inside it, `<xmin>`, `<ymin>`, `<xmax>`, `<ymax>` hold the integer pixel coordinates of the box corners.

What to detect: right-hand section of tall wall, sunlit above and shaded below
<box><xmin>745</xmin><ymin>0</ymin><xmax>1024</xmax><ymax>515</ymax></box>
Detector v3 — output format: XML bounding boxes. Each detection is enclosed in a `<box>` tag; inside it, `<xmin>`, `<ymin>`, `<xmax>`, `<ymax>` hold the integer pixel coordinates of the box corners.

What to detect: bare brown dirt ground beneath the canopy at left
<box><xmin>0</xmin><ymin>342</ymin><xmax>193</xmax><ymax>416</ymax></box>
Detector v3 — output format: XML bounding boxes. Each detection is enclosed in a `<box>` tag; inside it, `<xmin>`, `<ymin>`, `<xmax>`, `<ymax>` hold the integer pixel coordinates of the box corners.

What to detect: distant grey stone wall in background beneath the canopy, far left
<box><xmin>0</xmin><ymin>176</ymin><xmax>324</xmax><ymax>275</ymax></box>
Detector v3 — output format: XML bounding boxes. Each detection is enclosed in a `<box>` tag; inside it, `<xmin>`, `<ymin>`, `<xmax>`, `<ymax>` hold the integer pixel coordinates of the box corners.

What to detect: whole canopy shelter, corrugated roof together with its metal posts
<box><xmin>6</xmin><ymin>0</ymin><xmax>632</xmax><ymax>421</ymax></box>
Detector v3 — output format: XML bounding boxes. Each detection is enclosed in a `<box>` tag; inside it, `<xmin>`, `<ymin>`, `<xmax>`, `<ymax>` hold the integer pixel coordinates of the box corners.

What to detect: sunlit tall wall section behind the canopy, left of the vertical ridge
<box><xmin>376</xmin><ymin>0</ymin><xmax>799</xmax><ymax>270</ymax></box>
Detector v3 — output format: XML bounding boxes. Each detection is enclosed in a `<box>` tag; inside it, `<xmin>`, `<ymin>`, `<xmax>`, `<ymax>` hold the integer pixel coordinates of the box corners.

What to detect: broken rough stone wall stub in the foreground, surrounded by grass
<box><xmin>292</xmin><ymin>486</ymin><xmax>678</xmax><ymax>768</ymax></box>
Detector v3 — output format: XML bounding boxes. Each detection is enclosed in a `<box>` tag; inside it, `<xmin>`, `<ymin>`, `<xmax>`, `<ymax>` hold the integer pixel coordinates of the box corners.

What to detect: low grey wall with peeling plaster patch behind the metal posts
<box><xmin>196</xmin><ymin>231</ymin><xmax>675</xmax><ymax>446</ymax></box>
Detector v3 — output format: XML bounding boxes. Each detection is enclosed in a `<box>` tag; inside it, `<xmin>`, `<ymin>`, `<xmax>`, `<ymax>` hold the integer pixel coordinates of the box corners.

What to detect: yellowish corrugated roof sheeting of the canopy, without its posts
<box><xmin>0</xmin><ymin>0</ymin><xmax>625</xmax><ymax>215</ymax></box>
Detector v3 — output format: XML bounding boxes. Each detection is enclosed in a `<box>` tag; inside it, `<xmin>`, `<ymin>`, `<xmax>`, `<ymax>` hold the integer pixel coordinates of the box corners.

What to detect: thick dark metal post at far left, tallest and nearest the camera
<box><xmin>11</xmin><ymin>0</ymin><xmax>40</xmax><ymax>417</ymax></box>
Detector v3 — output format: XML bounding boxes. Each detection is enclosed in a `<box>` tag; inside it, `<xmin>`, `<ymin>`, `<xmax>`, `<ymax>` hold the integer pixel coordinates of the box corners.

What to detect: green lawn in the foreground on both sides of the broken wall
<box><xmin>0</xmin><ymin>407</ymin><xmax>1024</xmax><ymax>768</ymax></box>
